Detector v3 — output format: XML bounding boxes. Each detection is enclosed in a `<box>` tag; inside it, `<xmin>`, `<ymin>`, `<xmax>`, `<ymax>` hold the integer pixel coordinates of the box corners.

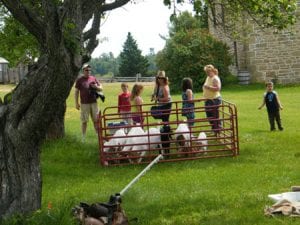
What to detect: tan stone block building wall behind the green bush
<box><xmin>209</xmin><ymin>1</ymin><xmax>300</xmax><ymax>84</ymax></box>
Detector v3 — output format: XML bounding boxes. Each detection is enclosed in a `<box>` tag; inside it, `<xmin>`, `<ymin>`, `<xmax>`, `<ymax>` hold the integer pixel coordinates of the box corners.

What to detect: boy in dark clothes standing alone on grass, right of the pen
<box><xmin>258</xmin><ymin>82</ymin><xmax>283</xmax><ymax>131</ymax></box>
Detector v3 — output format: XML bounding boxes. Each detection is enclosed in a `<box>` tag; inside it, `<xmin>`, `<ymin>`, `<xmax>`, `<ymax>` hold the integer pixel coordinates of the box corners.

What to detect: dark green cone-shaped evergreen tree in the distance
<box><xmin>119</xmin><ymin>32</ymin><xmax>149</xmax><ymax>77</ymax></box>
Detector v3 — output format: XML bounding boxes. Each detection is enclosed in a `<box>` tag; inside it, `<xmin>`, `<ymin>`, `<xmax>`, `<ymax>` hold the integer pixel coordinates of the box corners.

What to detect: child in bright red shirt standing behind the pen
<box><xmin>118</xmin><ymin>83</ymin><xmax>131</xmax><ymax>124</ymax></box>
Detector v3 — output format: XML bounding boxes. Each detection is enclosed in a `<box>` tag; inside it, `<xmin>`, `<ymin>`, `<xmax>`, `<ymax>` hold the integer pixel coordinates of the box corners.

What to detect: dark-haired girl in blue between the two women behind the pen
<box><xmin>182</xmin><ymin>78</ymin><xmax>195</xmax><ymax>127</ymax></box>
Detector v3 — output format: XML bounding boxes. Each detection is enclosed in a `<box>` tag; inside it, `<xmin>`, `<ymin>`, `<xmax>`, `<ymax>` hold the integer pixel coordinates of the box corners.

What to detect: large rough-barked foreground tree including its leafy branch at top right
<box><xmin>0</xmin><ymin>0</ymin><xmax>294</xmax><ymax>220</ymax></box>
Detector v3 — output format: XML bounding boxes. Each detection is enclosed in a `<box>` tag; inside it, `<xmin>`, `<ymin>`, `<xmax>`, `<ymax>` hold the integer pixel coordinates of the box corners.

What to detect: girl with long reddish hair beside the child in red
<box><xmin>130</xmin><ymin>84</ymin><xmax>144</xmax><ymax>125</ymax></box>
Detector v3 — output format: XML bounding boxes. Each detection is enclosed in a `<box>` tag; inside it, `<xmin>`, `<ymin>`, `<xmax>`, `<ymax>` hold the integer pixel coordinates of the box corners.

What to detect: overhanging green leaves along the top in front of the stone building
<box><xmin>164</xmin><ymin>0</ymin><xmax>297</xmax><ymax>30</ymax></box>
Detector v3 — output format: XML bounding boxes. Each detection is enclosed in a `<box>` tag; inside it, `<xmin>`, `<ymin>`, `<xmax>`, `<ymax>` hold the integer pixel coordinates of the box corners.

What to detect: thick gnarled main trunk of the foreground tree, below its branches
<box><xmin>0</xmin><ymin>54</ymin><xmax>79</xmax><ymax>218</ymax></box>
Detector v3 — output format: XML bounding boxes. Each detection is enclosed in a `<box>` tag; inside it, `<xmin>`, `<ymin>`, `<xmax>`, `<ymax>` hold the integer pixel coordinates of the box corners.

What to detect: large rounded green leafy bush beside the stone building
<box><xmin>157</xmin><ymin>12</ymin><xmax>232</xmax><ymax>91</ymax></box>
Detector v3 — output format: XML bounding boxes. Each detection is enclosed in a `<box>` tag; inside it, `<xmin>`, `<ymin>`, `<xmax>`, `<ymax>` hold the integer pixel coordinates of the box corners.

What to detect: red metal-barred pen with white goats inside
<box><xmin>98</xmin><ymin>99</ymin><xmax>239</xmax><ymax>165</ymax></box>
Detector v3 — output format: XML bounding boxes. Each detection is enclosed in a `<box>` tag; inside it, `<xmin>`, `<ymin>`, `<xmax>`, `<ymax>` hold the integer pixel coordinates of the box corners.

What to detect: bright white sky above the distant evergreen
<box><xmin>92</xmin><ymin>0</ymin><xmax>192</xmax><ymax>58</ymax></box>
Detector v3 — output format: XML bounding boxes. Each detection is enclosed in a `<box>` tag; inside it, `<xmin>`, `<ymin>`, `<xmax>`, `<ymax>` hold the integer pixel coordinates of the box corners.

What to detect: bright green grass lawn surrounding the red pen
<box><xmin>0</xmin><ymin>84</ymin><xmax>300</xmax><ymax>225</ymax></box>
